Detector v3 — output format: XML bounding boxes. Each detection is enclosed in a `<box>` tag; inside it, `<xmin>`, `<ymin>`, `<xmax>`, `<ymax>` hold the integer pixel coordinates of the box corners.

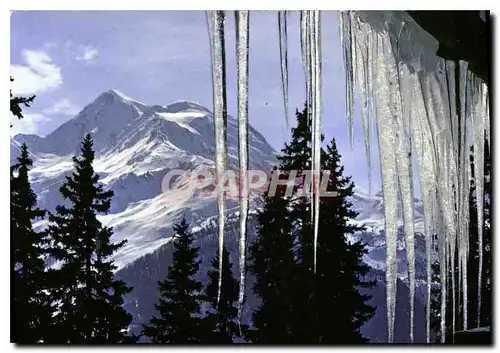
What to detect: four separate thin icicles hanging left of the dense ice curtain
<box><xmin>207</xmin><ymin>11</ymin><xmax>321</xmax><ymax>330</ymax></box>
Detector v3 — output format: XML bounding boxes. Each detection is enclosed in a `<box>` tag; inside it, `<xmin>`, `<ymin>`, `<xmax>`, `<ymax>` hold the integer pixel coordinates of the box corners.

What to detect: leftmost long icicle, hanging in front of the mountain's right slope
<box><xmin>208</xmin><ymin>11</ymin><xmax>227</xmax><ymax>305</ymax></box>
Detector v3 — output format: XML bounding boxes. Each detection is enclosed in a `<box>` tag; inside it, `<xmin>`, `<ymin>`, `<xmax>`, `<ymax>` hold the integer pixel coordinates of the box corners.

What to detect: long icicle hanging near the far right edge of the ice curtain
<box><xmin>473</xmin><ymin>75</ymin><xmax>486</xmax><ymax>327</ymax></box>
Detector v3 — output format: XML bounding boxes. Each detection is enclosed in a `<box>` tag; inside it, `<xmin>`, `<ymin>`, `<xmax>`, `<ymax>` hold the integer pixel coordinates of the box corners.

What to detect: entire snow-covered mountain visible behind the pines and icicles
<box><xmin>11</xmin><ymin>90</ymin><xmax>425</xmax><ymax>342</ymax></box>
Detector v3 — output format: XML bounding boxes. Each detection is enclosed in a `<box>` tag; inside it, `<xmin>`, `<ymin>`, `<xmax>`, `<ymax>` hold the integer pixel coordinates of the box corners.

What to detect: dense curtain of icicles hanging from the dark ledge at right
<box><xmin>340</xmin><ymin>11</ymin><xmax>490</xmax><ymax>342</ymax></box>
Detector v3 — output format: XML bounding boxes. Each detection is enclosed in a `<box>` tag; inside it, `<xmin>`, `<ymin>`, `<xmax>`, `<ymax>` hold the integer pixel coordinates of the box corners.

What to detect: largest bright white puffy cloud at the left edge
<box><xmin>10</xmin><ymin>50</ymin><xmax>63</xmax><ymax>95</ymax></box>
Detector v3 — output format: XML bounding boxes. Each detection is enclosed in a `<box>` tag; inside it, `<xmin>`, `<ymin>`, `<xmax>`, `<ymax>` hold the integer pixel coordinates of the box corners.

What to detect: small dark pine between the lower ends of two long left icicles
<box><xmin>201</xmin><ymin>247</ymin><xmax>246</xmax><ymax>344</ymax></box>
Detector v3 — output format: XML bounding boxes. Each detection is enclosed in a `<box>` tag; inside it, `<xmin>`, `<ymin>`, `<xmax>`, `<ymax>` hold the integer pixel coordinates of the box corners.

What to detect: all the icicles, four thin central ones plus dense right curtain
<box><xmin>203</xmin><ymin>11</ymin><xmax>489</xmax><ymax>342</ymax></box>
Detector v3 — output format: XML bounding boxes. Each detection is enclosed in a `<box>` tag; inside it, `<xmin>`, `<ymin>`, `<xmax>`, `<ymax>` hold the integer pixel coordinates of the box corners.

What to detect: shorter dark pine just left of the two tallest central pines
<box><xmin>249</xmin><ymin>177</ymin><xmax>295</xmax><ymax>344</ymax></box>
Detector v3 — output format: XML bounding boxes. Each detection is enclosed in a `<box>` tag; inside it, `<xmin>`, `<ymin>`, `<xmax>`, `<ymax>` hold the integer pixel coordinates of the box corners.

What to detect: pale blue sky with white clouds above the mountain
<box><xmin>10</xmin><ymin>11</ymin><xmax>380</xmax><ymax>190</ymax></box>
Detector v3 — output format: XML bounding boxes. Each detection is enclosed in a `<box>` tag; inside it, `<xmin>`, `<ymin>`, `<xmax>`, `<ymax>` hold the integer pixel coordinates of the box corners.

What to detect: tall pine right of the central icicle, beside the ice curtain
<box><xmin>311</xmin><ymin>139</ymin><xmax>375</xmax><ymax>343</ymax></box>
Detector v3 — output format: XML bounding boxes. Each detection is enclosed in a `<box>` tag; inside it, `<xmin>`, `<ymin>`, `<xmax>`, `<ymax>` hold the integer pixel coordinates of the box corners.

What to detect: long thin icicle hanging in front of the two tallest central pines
<box><xmin>311</xmin><ymin>11</ymin><xmax>321</xmax><ymax>273</ymax></box>
